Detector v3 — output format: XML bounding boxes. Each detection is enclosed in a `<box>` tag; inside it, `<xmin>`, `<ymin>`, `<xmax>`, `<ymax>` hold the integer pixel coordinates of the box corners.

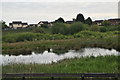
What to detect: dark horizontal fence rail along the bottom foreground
<box><xmin>2</xmin><ymin>73</ymin><xmax>120</xmax><ymax>80</ymax></box>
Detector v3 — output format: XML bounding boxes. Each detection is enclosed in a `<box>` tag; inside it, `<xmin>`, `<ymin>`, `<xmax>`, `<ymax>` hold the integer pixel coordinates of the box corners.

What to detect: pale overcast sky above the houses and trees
<box><xmin>0</xmin><ymin>0</ymin><xmax>118</xmax><ymax>24</ymax></box>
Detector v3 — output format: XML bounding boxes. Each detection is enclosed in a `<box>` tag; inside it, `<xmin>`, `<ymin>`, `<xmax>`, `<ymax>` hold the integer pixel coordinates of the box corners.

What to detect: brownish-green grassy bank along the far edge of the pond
<box><xmin>2</xmin><ymin>35</ymin><xmax>120</xmax><ymax>55</ymax></box>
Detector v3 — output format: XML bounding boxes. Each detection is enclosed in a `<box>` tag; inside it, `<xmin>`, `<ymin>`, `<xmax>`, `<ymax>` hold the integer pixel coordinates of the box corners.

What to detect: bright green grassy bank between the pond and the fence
<box><xmin>2</xmin><ymin>56</ymin><xmax>120</xmax><ymax>73</ymax></box>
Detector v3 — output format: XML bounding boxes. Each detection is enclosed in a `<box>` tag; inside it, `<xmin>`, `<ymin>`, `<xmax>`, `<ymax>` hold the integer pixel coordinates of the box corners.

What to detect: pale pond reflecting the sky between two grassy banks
<box><xmin>0</xmin><ymin>48</ymin><xmax>120</xmax><ymax>65</ymax></box>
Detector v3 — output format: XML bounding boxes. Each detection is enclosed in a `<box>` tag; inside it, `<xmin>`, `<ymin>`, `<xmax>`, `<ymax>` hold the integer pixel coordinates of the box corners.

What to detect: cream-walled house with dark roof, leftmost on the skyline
<box><xmin>9</xmin><ymin>21</ymin><xmax>28</xmax><ymax>29</ymax></box>
